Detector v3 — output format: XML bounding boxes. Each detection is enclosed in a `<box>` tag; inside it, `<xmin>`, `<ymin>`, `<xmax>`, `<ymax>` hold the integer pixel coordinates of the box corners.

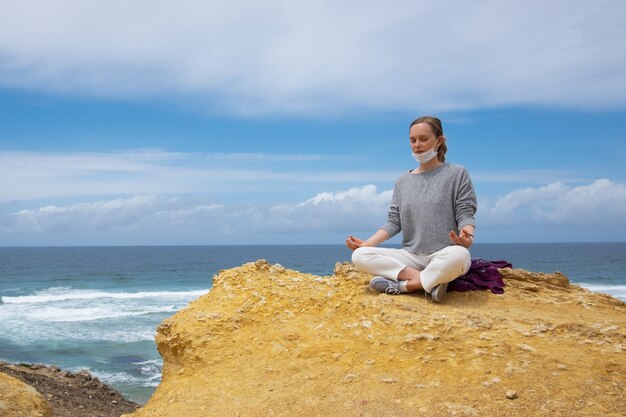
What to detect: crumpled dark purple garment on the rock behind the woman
<box><xmin>448</xmin><ymin>258</ymin><xmax>513</xmax><ymax>294</ymax></box>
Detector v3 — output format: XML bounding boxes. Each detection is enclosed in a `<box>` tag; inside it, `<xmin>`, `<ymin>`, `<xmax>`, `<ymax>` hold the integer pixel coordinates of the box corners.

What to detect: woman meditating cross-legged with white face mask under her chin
<box><xmin>346</xmin><ymin>116</ymin><xmax>476</xmax><ymax>303</ymax></box>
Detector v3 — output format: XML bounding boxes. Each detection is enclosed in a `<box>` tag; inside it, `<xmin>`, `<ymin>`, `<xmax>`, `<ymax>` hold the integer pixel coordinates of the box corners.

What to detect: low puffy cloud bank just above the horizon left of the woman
<box><xmin>0</xmin><ymin>185</ymin><xmax>391</xmax><ymax>244</ymax></box>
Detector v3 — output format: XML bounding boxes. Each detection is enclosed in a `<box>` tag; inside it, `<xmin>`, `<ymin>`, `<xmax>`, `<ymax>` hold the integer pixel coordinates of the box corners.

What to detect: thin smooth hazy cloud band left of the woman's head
<box><xmin>0</xmin><ymin>150</ymin><xmax>396</xmax><ymax>202</ymax></box>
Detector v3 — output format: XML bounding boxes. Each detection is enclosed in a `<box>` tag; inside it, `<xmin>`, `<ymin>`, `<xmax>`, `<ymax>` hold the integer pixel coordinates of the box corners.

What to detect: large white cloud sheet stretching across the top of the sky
<box><xmin>0</xmin><ymin>0</ymin><xmax>626</xmax><ymax>115</ymax></box>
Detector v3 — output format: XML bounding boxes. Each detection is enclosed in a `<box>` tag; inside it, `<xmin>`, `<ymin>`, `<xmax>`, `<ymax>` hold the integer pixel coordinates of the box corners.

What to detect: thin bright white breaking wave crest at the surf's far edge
<box><xmin>0</xmin><ymin>288</ymin><xmax>208</xmax><ymax>304</ymax></box>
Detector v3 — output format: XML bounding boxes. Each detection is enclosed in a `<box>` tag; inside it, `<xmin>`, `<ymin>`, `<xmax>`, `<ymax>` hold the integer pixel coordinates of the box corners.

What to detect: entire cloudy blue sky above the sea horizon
<box><xmin>0</xmin><ymin>0</ymin><xmax>626</xmax><ymax>246</ymax></box>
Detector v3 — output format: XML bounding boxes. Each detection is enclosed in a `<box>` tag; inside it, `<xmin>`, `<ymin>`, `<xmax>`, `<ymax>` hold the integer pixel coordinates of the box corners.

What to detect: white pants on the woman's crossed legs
<box><xmin>352</xmin><ymin>245</ymin><xmax>471</xmax><ymax>292</ymax></box>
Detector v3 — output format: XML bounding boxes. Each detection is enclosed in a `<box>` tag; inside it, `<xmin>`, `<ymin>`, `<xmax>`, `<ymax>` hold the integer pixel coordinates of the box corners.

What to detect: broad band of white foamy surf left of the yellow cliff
<box><xmin>0</xmin><ymin>287</ymin><xmax>206</xmax><ymax>344</ymax></box>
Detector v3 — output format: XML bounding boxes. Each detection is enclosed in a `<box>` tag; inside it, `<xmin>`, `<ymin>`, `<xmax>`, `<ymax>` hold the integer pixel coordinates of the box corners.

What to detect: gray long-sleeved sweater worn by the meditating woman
<box><xmin>381</xmin><ymin>163</ymin><xmax>477</xmax><ymax>256</ymax></box>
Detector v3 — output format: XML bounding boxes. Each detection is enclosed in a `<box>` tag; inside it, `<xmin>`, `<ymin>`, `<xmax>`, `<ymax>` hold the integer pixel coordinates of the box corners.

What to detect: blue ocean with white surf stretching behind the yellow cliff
<box><xmin>0</xmin><ymin>243</ymin><xmax>626</xmax><ymax>404</ymax></box>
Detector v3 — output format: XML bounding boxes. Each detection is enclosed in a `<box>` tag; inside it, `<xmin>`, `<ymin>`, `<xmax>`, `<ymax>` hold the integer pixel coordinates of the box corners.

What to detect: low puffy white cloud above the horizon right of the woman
<box><xmin>479</xmin><ymin>178</ymin><xmax>626</xmax><ymax>226</ymax></box>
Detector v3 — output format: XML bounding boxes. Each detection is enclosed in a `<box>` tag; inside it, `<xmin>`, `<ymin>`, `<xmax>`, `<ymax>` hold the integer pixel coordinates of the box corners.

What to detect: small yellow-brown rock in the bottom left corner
<box><xmin>0</xmin><ymin>372</ymin><xmax>52</xmax><ymax>417</ymax></box>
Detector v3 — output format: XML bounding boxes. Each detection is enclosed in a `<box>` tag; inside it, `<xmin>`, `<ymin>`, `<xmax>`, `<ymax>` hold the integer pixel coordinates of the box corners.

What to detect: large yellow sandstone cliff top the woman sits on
<box><xmin>124</xmin><ymin>260</ymin><xmax>626</xmax><ymax>417</ymax></box>
